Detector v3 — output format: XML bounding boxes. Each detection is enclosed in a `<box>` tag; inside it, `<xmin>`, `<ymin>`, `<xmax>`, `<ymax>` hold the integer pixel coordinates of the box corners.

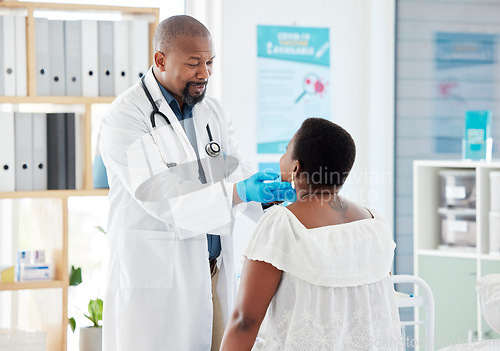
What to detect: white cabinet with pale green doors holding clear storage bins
<box><xmin>413</xmin><ymin>161</ymin><xmax>500</xmax><ymax>348</ymax></box>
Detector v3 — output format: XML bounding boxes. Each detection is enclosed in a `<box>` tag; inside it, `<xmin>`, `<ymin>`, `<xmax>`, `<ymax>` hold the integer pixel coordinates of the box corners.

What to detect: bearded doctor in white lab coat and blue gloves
<box><xmin>100</xmin><ymin>16</ymin><xmax>295</xmax><ymax>351</ymax></box>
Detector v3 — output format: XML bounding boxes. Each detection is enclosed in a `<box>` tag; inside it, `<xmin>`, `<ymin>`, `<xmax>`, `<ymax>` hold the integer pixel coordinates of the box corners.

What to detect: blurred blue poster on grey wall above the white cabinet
<box><xmin>433</xmin><ymin>32</ymin><xmax>498</xmax><ymax>154</ymax></box>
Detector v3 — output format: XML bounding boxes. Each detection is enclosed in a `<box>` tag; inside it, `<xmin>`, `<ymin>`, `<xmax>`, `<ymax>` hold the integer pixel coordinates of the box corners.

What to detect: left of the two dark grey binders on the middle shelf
<box><xmin>47</xmin><ymin>113</ymin><xmax>66</xmax><ymax>190</ymax></box>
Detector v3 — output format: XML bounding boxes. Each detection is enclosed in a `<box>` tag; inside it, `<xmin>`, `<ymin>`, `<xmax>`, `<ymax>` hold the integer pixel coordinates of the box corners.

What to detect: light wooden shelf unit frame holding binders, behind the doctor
<box><xmin>0</xmin><ymin>1</ymin><xmax>159</xmax><ymax>351</ymax></box>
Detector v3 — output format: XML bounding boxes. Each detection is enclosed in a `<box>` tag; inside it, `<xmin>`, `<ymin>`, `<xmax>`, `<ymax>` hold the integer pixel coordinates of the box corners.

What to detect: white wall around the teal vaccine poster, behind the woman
<box><xmin>219</xmin><ymin>0</ymin><xmax>395</xmax><ymax>223</ymax></box>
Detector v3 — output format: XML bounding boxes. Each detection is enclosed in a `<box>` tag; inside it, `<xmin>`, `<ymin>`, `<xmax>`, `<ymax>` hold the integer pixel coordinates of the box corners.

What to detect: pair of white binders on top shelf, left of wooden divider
<box><xmin>0</xmin><ymin>14</ymin><xmax>28</xmax><ymax>96</ymax></box>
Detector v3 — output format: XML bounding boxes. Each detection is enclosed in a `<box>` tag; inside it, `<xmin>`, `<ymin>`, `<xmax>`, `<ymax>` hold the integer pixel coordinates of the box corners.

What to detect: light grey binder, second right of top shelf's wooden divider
<box><xmin>49</xmin><ymin>20</ymin><xmax>66</xmax><ymax>96</ymax></box>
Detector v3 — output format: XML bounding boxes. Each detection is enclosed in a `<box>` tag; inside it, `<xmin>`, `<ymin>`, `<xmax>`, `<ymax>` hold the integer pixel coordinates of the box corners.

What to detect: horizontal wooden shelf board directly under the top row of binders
<box><xmin>0</xmin><ymin>96</ymin><xmax>116</xmax><ymax>105</ymax></box>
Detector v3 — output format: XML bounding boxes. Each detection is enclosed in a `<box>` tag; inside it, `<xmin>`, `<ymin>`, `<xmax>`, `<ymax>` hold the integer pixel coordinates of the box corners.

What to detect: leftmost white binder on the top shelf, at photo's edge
<box><xmin>0</xmin><ymin>15</ymin><xmax>16</xmax><ymax>96</ymax></box>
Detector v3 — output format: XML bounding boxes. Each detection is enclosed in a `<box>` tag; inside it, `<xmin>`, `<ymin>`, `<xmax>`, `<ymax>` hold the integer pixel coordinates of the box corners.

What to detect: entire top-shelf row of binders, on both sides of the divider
<box><xmin>0</xmin><ymin>13</ymin><xmax>150</xmax><ymax>97</ymax></box>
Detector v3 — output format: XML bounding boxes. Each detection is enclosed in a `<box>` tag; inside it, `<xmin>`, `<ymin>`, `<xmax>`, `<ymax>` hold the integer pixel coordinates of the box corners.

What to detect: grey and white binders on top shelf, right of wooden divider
<box><xmin>35</xmin><ymin>18</ymin><xmax>149</xmax><ymax>97</ymax></box>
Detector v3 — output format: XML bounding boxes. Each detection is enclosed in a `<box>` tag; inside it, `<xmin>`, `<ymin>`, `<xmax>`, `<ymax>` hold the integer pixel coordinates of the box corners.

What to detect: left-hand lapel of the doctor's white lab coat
<box><xmin>144</xmin><ymin>67</ymin><xmax>196</xmax><ymax>162</ymax></box>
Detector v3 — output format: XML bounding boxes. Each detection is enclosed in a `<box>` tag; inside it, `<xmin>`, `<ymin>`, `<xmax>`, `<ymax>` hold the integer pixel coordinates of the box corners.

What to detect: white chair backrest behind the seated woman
<box><xmin>392</xmin><ymin>274</ymin><xmax>434</xmax><ymax>350</ymax></box>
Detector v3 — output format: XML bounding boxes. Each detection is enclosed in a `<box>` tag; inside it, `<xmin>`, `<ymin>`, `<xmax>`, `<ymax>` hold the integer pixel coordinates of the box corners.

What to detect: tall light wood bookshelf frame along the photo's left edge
<box><xmin>0</xmin><ymin>1</ymin><xmax>159</xmax><ymax>351</ymax></box>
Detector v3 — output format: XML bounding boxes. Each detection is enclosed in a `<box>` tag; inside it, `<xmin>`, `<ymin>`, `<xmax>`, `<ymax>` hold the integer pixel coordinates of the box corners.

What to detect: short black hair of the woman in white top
<box><xmin>291</xmin><ymin>118</ymin><xmax>356</xmax><ymax>189</ymax></box>
